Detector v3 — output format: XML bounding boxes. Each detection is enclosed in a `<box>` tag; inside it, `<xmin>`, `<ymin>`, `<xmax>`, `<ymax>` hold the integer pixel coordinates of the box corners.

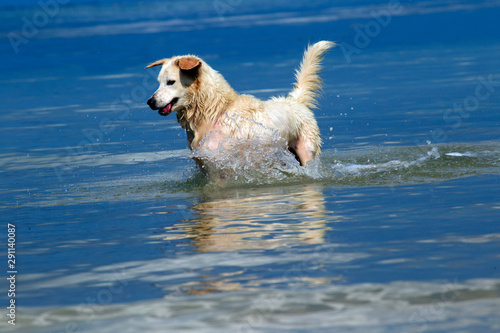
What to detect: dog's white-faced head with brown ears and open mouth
<box><xmin>146</xmin><ymin>56</ymin><xmax>202</xmax><ymax>116</ymax></box>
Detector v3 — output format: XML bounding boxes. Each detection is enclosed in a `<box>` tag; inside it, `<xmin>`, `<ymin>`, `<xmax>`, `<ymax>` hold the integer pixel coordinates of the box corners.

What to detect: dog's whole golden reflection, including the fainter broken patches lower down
<box><xmin>160</xmin><ymin>184</ymin><xmax>337</xmax><ymax>294</ymax></box>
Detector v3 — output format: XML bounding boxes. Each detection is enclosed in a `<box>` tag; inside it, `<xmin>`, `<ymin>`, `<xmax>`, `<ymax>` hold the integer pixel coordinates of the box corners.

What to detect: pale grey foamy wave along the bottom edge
<box><xmin>6</xmin><ymin>279</ymin><xmax>500</xmax><ymax>333</ymax></box>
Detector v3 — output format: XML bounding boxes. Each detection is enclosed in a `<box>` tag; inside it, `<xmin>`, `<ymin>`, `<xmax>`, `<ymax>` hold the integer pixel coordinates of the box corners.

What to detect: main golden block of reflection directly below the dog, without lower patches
<box><xmin>180</xmin><ymin>185</ymin><xmax>331</xmax><ymax>252</ymax></box>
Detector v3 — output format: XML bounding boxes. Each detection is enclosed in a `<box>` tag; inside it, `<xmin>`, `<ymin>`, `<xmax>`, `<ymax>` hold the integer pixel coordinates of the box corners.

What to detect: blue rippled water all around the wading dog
<box><xmin>0</xmin><ymin>0</ymin><xmax>500</xmax><ymax>332</ymax></box>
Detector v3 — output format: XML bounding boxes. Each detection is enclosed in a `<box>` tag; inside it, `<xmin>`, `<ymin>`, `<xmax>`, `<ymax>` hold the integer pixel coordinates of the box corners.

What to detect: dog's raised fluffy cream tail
<box><xmin>288</xmin><ymin>40</ymin><xmax>336</xmax><ymax>108</ymax></box>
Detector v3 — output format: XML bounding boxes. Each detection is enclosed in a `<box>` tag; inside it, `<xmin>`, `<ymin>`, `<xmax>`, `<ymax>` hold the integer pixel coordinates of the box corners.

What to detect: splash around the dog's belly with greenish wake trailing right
<box><xmin>188</xmin><ymin>136</ymin><xmax>500</xmax><ymax>187</ymax></box>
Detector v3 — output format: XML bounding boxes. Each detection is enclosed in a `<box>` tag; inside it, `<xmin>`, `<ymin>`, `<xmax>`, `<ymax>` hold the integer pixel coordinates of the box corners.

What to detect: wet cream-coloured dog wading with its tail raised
<box><xmin>146</xmin><ymin>41</ymin><xmax>335</xmax><ymax>166</ymax></box>
